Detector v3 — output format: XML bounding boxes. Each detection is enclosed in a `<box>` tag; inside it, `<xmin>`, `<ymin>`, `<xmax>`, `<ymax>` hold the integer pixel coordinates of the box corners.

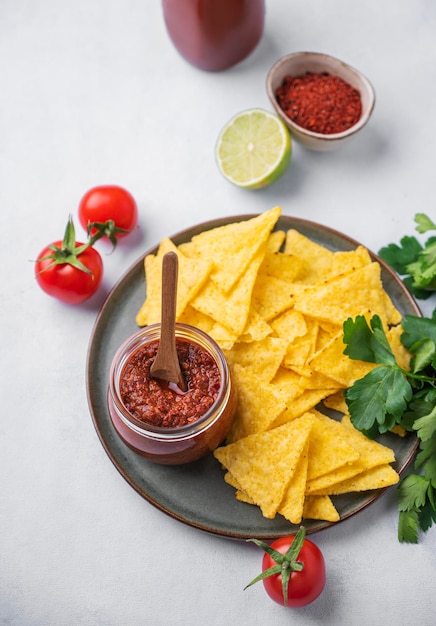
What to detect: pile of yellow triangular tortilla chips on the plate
<box><xmin>136</xmin><ymin>207</ymin><xmax>409</xmax><ymax>524</ymax></box>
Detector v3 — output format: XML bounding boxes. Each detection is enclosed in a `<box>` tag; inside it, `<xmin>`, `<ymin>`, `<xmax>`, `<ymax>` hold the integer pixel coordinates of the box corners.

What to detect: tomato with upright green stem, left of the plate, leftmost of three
<box><xmin>35</xmin><ymin>219</ymin><xmax>103</xmax><ymax>304</ymax></box>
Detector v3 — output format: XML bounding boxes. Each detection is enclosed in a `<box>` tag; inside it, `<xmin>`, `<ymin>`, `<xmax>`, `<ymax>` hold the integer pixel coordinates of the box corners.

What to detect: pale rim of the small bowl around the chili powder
<box><xmin>266</xmin><ymin>51</ymin><xmax>376</xmax><ymax>142</ymax></box>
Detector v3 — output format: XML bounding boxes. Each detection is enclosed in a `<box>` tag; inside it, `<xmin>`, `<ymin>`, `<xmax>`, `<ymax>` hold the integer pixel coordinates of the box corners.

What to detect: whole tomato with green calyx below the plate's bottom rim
<box><xmin>247</xmin><ymin>528</ymin><xmax>326</xmax><ymax>607</ymax></box>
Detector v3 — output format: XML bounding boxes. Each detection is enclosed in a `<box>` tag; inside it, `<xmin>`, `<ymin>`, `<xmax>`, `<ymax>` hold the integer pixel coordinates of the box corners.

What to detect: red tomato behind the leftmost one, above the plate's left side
<box><xmin>79</xmin><ymin>185</ymin><xmax>138</xmax><ymax>238</ymax></box>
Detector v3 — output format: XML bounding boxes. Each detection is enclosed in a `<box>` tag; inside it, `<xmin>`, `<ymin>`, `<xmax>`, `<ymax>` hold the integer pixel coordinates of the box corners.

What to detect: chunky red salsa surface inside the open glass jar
<box><xmin>120</xmin><ymin>339</ymin><xmax>221</xmax><ymax>428</ymax></box>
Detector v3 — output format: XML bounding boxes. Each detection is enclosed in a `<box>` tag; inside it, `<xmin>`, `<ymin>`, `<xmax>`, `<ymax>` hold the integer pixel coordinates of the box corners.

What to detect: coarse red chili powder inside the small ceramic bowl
<box><xmin>276</xmin><ymin>72</ymin><xmax>362</xmax><ymax>135</ymax></box>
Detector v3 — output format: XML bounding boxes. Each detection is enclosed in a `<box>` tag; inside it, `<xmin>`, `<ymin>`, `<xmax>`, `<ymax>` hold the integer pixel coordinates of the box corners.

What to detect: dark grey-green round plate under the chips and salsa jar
<box><xmin>87</xmin><ymin>215</ymin><xmax>420</xmax><ymax>540</ymax></box>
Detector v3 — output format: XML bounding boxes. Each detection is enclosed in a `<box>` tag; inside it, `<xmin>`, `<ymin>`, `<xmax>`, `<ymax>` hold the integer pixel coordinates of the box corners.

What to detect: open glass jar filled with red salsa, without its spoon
<box><xmin>108</xmin><ymin>323</ymin><xmax>236</xmax><ymax>465</ymax></box>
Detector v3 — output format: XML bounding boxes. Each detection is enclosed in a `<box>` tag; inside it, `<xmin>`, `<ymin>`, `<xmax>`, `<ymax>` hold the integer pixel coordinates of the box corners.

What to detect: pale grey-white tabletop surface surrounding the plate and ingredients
<box><xmin>0</xmin><ymin>0</ymin><xmax>436</xmax><ymax>626</ymax></box>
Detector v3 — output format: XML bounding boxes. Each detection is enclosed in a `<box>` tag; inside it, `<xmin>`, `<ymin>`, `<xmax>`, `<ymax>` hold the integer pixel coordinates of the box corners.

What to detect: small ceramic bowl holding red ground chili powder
<box><xmin>266</xmin><ymin>52</ymin><xmax>375</xmax><ymax>150</ymax></box>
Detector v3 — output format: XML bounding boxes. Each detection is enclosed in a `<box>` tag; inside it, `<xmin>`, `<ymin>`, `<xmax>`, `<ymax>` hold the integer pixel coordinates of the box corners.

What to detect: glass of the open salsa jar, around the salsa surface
<box><xmin>108</xmin><ymin>323</ymin><xmax>237</xmax><ymax>465</ymax></box>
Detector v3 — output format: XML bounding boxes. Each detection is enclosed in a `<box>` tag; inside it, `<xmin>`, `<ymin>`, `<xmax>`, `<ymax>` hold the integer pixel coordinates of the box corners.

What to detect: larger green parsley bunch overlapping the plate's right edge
<box><xmin>344</xmin><ymin>310</ymin><xmax>436</xmax><ymax>543</ymax></box>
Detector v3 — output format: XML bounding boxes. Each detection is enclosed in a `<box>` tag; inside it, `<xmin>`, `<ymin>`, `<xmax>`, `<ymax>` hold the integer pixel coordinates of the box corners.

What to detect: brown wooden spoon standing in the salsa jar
<box><xmin>150</xmin><ymin>252</ymin><xmax>186</xmax><ymax>391</ymax></box>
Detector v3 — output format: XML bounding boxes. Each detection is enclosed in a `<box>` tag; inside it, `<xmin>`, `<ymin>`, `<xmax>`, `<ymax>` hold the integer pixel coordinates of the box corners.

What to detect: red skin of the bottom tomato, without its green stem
<box><xmin>262</xmin><ymin>536</ymin><xmax>326</xmax><ymax>607</ymax></box>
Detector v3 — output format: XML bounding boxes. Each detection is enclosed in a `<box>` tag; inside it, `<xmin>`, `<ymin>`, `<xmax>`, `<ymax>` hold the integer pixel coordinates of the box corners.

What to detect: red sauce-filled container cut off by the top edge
<box><xmin>162</xmin><ymin>0</ymin><xmax>265</xmax><ymax>71</ymax></box>
